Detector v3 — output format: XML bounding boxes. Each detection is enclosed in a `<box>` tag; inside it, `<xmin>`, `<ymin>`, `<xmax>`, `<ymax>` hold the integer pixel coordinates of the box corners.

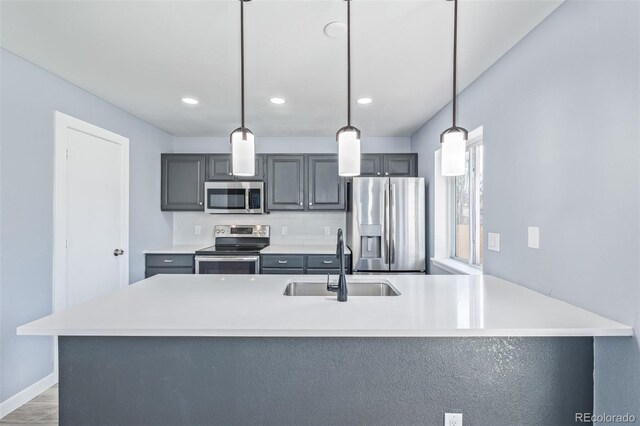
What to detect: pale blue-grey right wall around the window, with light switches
<box><xmin>412</xmin><ymin>0</ymin><xmax>640</xmax><ymax>417</ymax></box>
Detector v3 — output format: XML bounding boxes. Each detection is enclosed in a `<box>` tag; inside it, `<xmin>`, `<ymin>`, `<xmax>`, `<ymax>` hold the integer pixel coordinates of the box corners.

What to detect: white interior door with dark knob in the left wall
<box><xmin>54</xmin><ymin>113</ymin><xmax>129</xmax><ymax>311</ymax></box>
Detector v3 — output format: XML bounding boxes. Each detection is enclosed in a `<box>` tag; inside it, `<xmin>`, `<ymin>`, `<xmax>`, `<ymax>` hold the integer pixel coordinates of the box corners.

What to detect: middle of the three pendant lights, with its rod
<box><xmin>336</xmin><ymin>0</ymin><xmax>360</xmax><ymax>176</ymax></box>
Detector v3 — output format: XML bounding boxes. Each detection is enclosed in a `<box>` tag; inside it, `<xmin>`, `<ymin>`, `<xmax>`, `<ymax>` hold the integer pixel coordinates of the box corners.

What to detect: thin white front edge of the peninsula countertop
<box><xmin>17</xmin><ymin>327</ymin><xmax>634</xmax><ymax>338</ymax></box>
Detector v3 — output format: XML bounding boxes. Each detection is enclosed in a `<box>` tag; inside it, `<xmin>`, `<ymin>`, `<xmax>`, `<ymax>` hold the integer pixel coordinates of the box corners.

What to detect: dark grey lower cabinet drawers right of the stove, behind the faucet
<box><xmin>261</xmin><ymin>254</ymin><xmax>351</xmax><ymax>275</ymax></box>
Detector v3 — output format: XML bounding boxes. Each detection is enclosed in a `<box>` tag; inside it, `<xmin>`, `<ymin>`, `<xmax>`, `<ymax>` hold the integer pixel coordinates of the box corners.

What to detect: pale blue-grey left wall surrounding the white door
<box><xmin>0</xmin><ymin>50</ymin><xmax>172</xmax><ymax>401</ymax></box>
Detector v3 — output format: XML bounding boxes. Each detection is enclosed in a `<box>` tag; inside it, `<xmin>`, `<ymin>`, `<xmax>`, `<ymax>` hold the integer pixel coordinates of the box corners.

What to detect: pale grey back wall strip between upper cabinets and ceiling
<box><xmin>173</xmin><ymin>135</ymin><xmax>410</xmax><ymax>154</ymax></box>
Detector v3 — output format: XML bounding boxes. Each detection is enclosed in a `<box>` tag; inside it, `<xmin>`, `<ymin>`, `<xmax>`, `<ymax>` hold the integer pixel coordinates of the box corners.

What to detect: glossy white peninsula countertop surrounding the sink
<box><xmin>18</xmin><ymin>275</ymin><xmax>633</xmax><ymax>337</ymax></box>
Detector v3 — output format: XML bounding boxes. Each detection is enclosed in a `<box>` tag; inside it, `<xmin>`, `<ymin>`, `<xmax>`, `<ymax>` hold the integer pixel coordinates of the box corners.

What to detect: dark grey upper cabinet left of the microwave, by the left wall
<box><xmin>160</xmin><ymin>154</ymin><xmax>205</xmax><ymax>211</ymax></box>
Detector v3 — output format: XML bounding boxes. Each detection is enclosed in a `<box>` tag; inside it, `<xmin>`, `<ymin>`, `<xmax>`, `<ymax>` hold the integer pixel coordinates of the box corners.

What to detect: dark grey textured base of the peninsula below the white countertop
<box><xmin>59</xmin><ymin>336</ymin><xmax>593</xmax><ymax>426</ymax></box>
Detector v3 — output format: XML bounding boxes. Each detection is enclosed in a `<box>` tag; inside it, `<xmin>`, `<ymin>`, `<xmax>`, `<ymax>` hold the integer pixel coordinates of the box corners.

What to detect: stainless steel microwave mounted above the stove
<box><xmin>204</xmin><ymin>182</ymin><xmax>264</xmax><ymax>214</ymax></box>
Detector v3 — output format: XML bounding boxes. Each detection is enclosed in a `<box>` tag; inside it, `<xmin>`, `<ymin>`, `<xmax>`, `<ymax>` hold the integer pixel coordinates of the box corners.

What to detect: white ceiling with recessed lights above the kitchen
<box><xmin>1</xmin><ymin>0</ymin><xmax>562</xmax><ymax>137</ymax></box>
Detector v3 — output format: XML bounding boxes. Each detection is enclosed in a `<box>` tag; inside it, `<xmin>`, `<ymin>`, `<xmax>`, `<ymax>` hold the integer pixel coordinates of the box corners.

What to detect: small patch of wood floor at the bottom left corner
<box><xmin>0</xmin><ymin>385</ymin><xmax>58</xmax><ymax>426</ymax></box>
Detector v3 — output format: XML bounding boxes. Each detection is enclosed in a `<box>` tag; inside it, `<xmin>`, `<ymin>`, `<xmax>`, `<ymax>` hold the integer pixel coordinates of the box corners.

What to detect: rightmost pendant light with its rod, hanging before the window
<box><xmin>440</xmin><ymin>0</ymin><xmax>469</xmax><ymax>176</ymax></box>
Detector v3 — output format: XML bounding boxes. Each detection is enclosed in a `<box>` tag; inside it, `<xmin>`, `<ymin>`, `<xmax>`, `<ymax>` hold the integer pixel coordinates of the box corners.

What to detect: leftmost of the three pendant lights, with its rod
<box><xmin>231</xmin><ymin>0</ymin><xmax>256</xmax><ymax>176</ymax></box>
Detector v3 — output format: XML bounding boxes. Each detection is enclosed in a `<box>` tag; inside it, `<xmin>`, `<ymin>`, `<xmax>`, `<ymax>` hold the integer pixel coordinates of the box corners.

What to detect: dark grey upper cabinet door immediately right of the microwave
<box><xmin>266</xmin><ymin>155</ymin><xmax>305</xmax><ymax>210</ymax></box>
